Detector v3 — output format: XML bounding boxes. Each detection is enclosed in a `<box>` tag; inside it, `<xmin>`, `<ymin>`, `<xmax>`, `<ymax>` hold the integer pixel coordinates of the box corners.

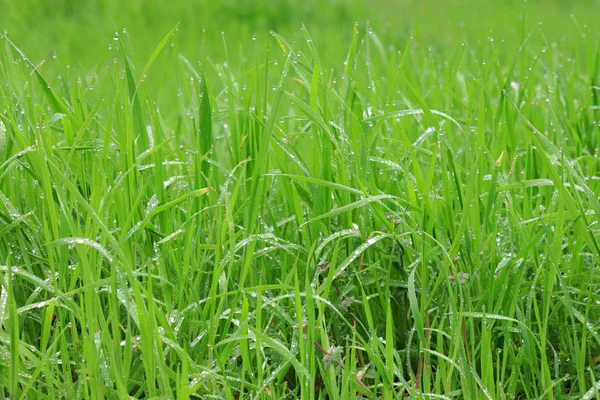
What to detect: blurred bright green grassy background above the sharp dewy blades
<box><xmin>0</xmin><ymin>0</ymin><xmax>600</xmax><ymax>69</ymax></box>
